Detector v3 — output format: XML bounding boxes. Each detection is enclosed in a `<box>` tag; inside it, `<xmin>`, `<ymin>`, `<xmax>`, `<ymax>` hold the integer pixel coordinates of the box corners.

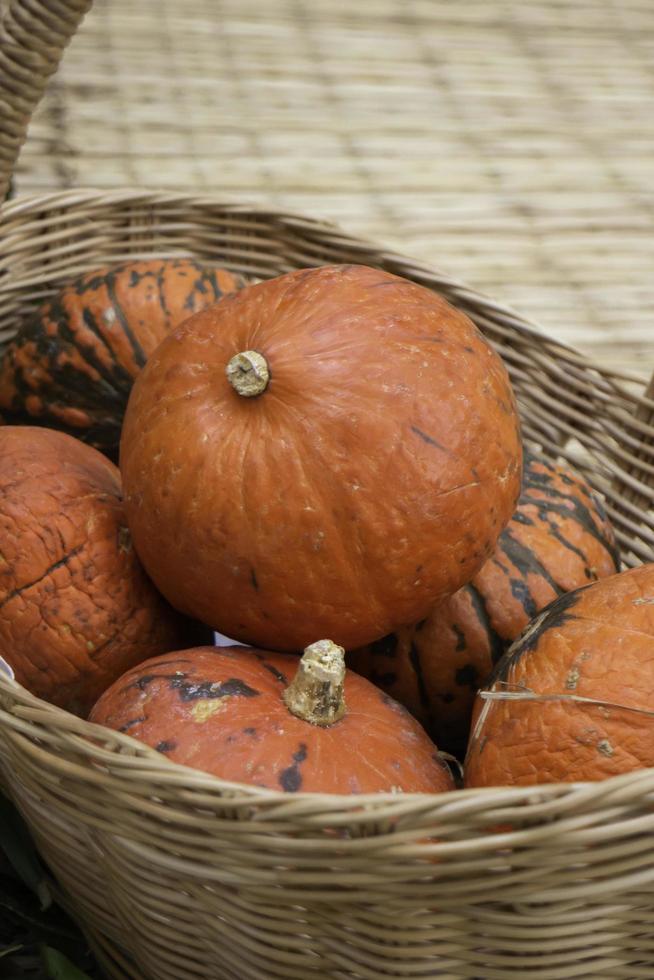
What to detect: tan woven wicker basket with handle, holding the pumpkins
<box><xmin>0</xmin><ymin>0</ymin><xmax>654</xmax><ymax>980</ymax></box>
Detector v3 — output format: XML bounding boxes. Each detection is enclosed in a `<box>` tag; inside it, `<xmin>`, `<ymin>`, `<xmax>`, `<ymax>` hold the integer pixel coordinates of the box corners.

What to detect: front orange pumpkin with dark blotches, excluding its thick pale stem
<box><xmin>89</xmin><ymin>647</ymin><xmax>454</xmax><ymax>794</ymax></box>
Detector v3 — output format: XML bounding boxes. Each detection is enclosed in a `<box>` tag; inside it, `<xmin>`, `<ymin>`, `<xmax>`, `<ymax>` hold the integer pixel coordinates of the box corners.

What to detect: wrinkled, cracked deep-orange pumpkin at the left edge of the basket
<box><xmin>0</xmin><ymin>426</ymin><xmax>193</xmax><ymax>716</ymax></box>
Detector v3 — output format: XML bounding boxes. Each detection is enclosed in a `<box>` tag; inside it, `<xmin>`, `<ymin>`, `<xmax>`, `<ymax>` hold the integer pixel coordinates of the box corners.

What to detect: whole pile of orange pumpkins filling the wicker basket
<box><xmin>0</xmin><ymin>259</ymin><xmax>654</xmax><ymax>793</ymax></box>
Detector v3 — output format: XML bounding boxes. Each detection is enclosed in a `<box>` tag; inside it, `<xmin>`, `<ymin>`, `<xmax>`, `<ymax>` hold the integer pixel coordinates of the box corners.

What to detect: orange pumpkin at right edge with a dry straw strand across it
<box><xmin>465</xmin><ymin>564</ymin><xmax>654</xmax><ymax>787</ymax></box>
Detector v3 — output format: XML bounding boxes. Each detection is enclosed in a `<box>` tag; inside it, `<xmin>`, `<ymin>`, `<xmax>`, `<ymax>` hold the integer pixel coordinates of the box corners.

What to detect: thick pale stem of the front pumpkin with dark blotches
<box><xmin>282</xmin><ymin>640</ymin><xmax>352</xmax><ymax>725</ymax></box>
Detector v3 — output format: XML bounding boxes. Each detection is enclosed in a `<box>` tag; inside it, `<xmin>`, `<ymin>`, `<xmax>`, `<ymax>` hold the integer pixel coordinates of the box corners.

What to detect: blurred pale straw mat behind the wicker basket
<box><xmin>9</xmin><ymin>0</ymin><xmax>654</xmax><ymax>377</ymax></box>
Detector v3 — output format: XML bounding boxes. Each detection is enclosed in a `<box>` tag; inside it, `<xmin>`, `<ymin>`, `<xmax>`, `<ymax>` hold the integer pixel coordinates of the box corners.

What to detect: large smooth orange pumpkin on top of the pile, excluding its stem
<box><xmin>120</xmin><ymin>266</ymin><xmax>522</xmax><ymax>651</ymax></box>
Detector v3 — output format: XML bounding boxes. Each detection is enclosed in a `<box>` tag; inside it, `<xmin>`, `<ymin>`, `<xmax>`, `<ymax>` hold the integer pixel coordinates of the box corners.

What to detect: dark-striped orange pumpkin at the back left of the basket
<box><xmin>0</xmin><ymin>259</ymin><xmax>243</xmax><ymax>458</ymax></box>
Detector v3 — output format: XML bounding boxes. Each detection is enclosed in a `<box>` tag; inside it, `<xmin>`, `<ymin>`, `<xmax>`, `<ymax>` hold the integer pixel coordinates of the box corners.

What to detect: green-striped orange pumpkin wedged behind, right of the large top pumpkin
<box><xmin>348</xmin><ymin>454</ymin><xmax>619</xmax><ymax>758</ymax></box>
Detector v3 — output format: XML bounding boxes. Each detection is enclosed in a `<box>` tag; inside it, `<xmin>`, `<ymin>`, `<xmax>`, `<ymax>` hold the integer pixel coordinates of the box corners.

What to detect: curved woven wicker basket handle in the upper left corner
<box><xmin>0</xmin><ymin>0</ymin><xmax>92</xmax><ymax>201</ymax></box>
